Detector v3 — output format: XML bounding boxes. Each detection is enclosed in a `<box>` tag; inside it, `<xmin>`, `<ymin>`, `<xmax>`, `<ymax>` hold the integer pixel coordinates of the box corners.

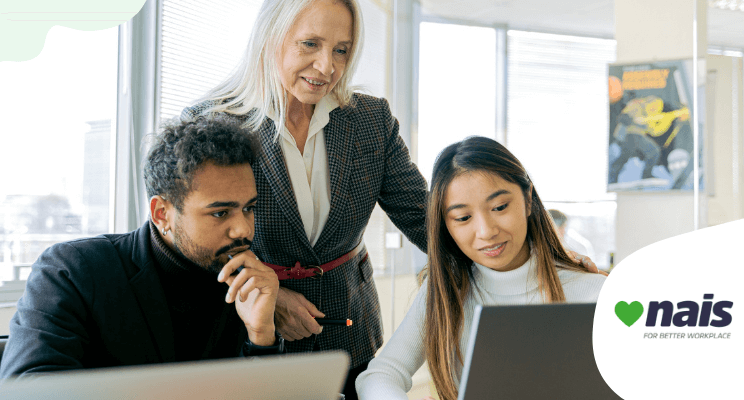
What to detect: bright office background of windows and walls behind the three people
<box><xmin>0</xmin><ymin>0</ymin><xmax>744</xmax><ymax>396</ymax></box>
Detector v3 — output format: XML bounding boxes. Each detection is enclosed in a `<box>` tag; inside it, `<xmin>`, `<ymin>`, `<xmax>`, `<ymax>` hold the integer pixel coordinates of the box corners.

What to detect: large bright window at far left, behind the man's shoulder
<box><xmin>0</xmin><ymin>27</ymin><xmax>118</xmax><ymax>282</ymax></box>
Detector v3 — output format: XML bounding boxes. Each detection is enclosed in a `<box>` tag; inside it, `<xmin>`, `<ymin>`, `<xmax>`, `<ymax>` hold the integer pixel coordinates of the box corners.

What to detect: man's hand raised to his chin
<box><xmin>217</xmin><ymin>250</ymin><xmax>279</xmax><ymax>346</ymax></box>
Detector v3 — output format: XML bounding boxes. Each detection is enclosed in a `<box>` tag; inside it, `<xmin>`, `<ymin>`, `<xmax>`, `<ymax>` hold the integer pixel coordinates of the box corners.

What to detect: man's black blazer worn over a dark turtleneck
<box><xmin>0</xmin><ymin>223</ymin><xmax>247</xmax><ymax>378</ymax></box>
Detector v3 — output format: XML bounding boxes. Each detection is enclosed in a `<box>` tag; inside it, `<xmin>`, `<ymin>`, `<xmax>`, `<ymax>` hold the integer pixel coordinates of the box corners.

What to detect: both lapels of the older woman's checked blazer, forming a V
<box><xmin>259</xmin><ymin>108</ymin><xmax>356</xmax><ymax>262</ymax></box>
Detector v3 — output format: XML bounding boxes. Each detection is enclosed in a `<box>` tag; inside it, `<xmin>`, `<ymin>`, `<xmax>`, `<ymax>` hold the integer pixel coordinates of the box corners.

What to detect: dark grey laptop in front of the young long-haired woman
<box><xmin>458</xmin><ymin>304</ymin><xmax>621</xmax><ymax>400</ymax></box>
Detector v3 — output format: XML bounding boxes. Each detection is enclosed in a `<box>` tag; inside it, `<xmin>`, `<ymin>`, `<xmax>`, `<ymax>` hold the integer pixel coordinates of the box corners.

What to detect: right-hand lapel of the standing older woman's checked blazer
<box><xmin>315</xmin><ymin>108</ymin><xmax>355</xmax><ymax>249</ymax></box>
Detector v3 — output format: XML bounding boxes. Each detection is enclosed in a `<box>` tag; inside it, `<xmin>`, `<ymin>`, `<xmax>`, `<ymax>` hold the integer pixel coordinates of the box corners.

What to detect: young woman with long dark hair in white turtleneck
<box><xmin>357</xmin><ymin>137</ymin><xmax>605</xmax><ymax>400</ymax></box>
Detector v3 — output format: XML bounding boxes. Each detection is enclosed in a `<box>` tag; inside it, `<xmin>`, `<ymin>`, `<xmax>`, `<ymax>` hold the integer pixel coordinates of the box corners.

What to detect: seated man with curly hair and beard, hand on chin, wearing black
<box><xmin>0</xmin><ymin>117</ymin><xmax>283</xmax><ymax>378</ymax></box>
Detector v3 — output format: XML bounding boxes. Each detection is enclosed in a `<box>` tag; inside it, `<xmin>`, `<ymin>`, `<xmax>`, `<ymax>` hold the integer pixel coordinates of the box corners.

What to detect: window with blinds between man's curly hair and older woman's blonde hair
<box><xmin>160</xmin><ymin>0</ymin><xmax>261</xmax><ymax>121</ymax></box>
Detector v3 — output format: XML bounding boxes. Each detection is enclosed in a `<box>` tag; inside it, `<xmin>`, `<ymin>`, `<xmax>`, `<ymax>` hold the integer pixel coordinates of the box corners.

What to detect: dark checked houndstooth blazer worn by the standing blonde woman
<box><xmin>181</xmin><ymin>94</ymin><xmax>427</xmax><ymax>368</ymax></box>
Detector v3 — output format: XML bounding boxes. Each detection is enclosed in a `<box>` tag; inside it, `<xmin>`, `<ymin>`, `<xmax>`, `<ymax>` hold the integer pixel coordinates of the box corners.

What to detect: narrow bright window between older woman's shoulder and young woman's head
<box><xmin>418</xmin><ymin>22</ymin><xmax>496</xmax><ymax>183</ymax></box>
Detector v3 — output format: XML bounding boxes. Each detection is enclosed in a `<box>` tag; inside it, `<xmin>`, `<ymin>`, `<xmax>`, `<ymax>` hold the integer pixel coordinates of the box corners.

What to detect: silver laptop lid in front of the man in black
<box><xmin>0</xmin><ymin>352</ymin><xmax>349</xmax><ymax>400</ymax></box>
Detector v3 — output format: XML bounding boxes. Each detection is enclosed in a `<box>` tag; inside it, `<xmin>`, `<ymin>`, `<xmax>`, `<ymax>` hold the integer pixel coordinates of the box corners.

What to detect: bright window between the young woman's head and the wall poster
<box><xmin>507</xmin><ymin>30</ymin><xmax>616</xmax><ymax>268</ymax></box>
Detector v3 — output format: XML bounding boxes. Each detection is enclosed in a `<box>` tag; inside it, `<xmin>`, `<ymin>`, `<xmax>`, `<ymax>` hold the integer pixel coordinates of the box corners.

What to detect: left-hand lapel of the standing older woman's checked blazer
<box><xmin>259</xmin><ymin>118</ymin><xmax>312</xmax><ymax>252</ymax></box>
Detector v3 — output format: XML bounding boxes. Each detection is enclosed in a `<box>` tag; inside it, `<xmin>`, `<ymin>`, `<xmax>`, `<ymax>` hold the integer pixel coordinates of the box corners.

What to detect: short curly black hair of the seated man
<box><xmin>144</xmin><ymin>114</ymin><xmax>260</xmax><ymax>212</ymax></box>
